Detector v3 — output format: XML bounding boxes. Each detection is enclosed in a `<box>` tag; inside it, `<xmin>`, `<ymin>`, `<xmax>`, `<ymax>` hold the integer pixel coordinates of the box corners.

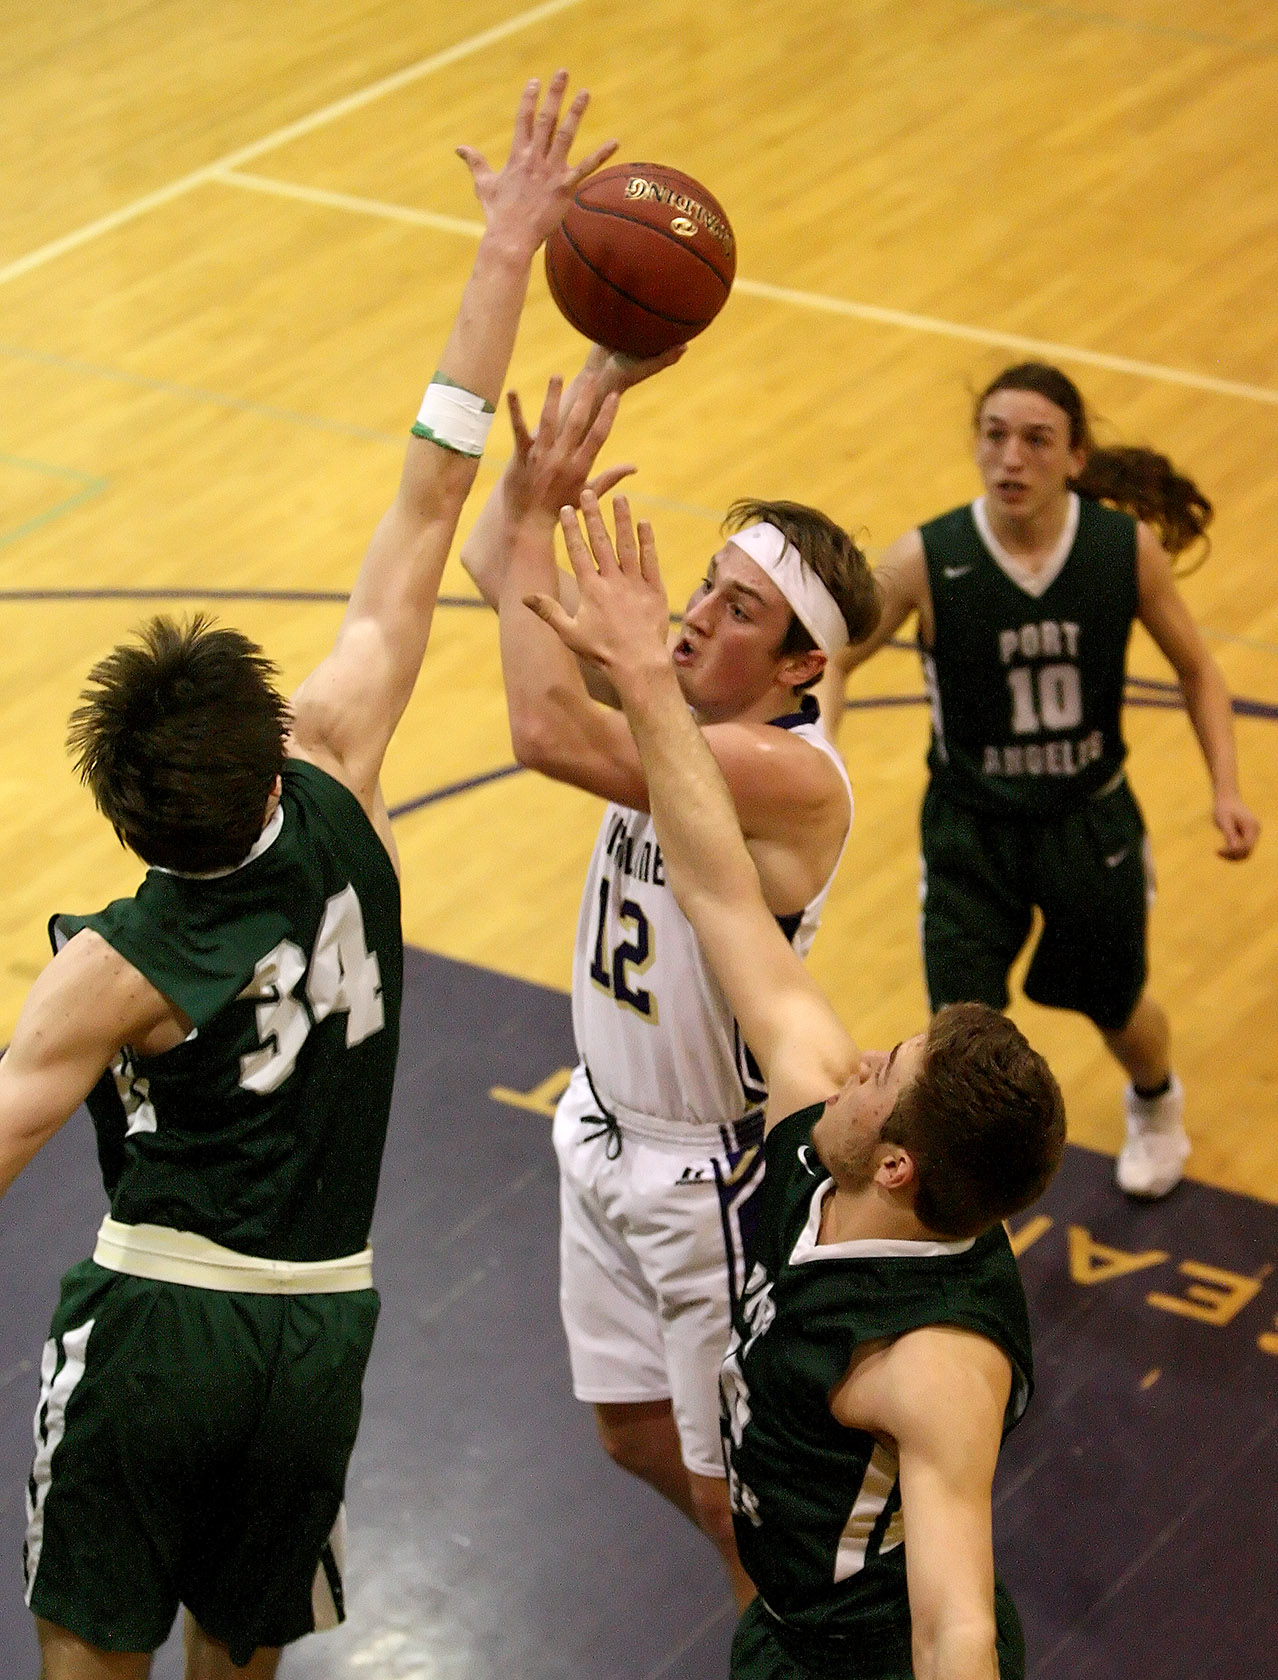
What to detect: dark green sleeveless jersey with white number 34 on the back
<box><xmin>50</xmin><ymin>759</ymin><xmax>403</xmax><ymax>1260</ymax></box>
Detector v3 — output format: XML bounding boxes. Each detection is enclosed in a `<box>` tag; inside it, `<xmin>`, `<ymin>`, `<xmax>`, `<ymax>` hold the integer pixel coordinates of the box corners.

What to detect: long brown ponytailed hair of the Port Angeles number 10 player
<box><xmin>972</xmin><ymin>361</ymin><xmax>1214</xmax><ymax>576</ymax></box>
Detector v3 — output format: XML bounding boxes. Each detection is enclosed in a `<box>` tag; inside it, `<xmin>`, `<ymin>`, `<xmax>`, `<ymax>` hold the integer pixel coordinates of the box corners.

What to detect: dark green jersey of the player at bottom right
<box><xmin>720</xmin><ymin>1105</ymin><xmax>1033</xmax><ymax>1677</ymax></box>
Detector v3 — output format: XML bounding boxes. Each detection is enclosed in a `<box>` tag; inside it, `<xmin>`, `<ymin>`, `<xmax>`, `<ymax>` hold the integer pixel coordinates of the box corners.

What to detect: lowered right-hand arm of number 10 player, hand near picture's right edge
<box><xmin>1137</xmin><ymin>524</ymin><xmax>1260</xmax><ymax>862</ymax></box>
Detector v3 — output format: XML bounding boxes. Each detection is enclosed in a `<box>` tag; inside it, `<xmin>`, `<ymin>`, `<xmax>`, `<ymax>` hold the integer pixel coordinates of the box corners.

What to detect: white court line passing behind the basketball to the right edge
<box><xmin>215</xmin><ymin>168</ymin><xmax>1278</xmax><ymax>405</ymax></box>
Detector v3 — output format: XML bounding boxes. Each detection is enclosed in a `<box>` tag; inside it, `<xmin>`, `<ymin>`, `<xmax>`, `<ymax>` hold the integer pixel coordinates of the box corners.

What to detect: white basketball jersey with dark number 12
<box><xmin>573</xmin><ymin>712</ymin><xmax>851</xmax><ymax>1126</ymax></box>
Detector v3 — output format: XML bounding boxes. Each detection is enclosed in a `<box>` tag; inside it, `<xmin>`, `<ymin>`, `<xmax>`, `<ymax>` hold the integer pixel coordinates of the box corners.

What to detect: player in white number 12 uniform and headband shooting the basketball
<box><xmin>462</xmin><ymin>367</ymin><xmax>878</xmax><ymax>1603</ymax></box>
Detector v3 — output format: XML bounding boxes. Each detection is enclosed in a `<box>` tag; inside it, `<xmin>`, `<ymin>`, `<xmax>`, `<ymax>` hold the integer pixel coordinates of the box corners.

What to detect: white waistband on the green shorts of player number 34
<box><xmin>92</xmin><ymin>1213</ymin><xmax>373</xmax><ymax>1295</ymax></box>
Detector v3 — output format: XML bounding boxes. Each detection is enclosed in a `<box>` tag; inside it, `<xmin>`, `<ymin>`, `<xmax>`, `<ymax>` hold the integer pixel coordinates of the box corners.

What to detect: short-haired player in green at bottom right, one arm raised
<box><xmin>529</xmin><ymin>492</ymin><xmax>1065</xmax><ymax>1680</ymax></box>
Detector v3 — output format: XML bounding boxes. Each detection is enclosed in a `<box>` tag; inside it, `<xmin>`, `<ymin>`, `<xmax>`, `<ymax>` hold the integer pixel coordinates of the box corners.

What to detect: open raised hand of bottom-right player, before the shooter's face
<box><xmin>524</xmin><ymin>489</ymin><xmax>672</xmax><ymax>685</ymax></box>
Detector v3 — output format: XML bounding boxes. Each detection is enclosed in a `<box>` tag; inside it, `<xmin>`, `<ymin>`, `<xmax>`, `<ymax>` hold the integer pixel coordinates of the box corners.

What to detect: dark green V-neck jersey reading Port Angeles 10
<box><xmin>920</xmin><ymin>497</ymin><xmax>1139</xmax><ymax>816</ymax></box>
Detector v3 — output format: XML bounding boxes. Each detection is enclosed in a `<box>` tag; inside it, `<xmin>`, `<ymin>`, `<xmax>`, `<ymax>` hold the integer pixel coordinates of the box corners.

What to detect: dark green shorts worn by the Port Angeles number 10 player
<box><xmin>922</xmin><ymin>781</ymin><xmax>1154</xmax><ymax>1032</ymax></box>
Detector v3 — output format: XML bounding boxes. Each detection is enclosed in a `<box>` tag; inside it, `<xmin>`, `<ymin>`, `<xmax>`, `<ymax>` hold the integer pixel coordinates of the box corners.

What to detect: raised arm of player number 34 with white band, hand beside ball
<box><xmin>291</xmin><ymin>71</ymin><xmax>615</xmax><ymax>840</ymax></box>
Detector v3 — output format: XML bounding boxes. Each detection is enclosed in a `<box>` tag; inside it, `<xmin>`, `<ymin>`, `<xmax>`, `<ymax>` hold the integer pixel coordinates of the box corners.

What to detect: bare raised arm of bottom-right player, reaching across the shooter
<box><xmin>527</xmin><ymin>491</ymin><xmax>856</xmax><ymax>1121</ymax></box>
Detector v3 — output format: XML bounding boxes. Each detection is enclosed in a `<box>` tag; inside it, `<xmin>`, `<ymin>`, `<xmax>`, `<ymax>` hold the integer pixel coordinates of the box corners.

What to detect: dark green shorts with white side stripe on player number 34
<box><xmin>24</xmin><ymin>1260</ymin><xmax>378</xmax><ymax>1665</ymax></box>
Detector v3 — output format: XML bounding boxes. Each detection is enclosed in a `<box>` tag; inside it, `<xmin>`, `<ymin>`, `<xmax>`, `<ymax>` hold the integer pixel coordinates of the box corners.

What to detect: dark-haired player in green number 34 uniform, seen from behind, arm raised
<box><xmin>0</xmin><ymin>72</ymin><xmax>613</xmax><ymax>1680</ymax></box>
